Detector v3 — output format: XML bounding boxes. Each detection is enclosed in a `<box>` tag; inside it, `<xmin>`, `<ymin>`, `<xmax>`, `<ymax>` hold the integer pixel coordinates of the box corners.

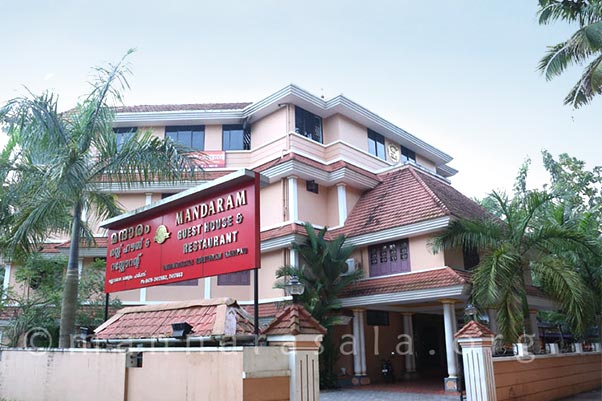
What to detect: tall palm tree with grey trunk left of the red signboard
<box><xmin>0</xmin><ymin>50</ymin><xmax>194</xmax><ymax>347</ymax></box>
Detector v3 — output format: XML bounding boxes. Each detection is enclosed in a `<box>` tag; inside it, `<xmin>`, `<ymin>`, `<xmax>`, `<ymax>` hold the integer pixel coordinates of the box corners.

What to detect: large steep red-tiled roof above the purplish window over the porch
<box><xmin>340</xmin><ymin>165</ymin><xmax>489</xmax><ymax>237</ymax></box>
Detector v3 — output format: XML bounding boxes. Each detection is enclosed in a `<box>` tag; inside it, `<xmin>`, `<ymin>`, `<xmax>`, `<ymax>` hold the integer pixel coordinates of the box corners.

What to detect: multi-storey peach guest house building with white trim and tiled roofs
<box><xmin>3</xmin><ymin>85</ymin><xmax>548</xmax><ymax>384</ymax></box>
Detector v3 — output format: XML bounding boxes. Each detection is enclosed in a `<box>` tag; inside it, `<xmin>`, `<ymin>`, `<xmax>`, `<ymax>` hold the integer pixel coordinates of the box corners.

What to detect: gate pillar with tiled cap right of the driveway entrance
<box><xmin>456</xmin><ymin>321</ymin><xmax>496</xmax><ymax>401</ymax></box>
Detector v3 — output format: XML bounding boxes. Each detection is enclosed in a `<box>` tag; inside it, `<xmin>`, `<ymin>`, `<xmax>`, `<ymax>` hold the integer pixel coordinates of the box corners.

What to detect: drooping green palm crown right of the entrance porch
<box><xmin>434</xmin><ymin>191</ymin><xmax>597</xmax><ymax>342</ymax></box>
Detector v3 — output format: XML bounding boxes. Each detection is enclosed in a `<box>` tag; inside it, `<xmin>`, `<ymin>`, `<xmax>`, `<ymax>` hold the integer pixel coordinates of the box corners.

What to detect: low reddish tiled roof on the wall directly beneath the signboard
<box><xmin>94</xmin><ymin>298</ymin><xmax>253</xmax><ymax>339</ymax></box>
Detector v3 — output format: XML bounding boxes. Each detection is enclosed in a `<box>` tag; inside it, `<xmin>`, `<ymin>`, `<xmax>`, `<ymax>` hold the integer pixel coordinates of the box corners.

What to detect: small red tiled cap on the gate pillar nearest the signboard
<box><xmin>261</xmin><ymin>304</ymin><xmax>326</xmax><ymax>336</ymax></box>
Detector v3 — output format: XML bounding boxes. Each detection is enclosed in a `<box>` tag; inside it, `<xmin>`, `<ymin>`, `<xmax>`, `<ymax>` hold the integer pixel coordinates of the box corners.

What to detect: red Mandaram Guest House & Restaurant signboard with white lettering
<box><xmin>103</xmin><ymin>170</ymin><xmax>260</xmax><ymax>293</ymax></box>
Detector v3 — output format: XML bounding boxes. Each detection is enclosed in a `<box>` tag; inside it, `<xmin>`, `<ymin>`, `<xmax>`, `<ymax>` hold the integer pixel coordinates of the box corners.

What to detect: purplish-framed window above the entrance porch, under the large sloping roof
<box><xmin>368</xmin><ymin>239</ymin><xmax>410</xmax><ymax>277</ymax></box>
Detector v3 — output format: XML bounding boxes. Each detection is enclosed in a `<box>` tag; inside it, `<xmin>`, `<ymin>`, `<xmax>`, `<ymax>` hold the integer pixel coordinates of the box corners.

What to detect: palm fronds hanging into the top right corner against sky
<box><xmin>538</xmin><ymin>0</ymin><xmax>602</xmax><ymax>108</ymax></box>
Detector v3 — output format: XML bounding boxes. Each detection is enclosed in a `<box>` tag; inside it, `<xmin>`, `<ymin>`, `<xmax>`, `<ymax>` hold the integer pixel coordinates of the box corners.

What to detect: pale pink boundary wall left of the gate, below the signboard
<box><xmin>0</xmin><ymin>347</ymin><xmax>290</xmax><ymax>401</ymax></box>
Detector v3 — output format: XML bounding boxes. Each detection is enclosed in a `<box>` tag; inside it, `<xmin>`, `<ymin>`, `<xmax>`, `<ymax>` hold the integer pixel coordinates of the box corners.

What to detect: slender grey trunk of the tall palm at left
<box><xmin>59</xmin><ymin>202</ymin><xmax>82</xmax><ymax>348</ymax></box>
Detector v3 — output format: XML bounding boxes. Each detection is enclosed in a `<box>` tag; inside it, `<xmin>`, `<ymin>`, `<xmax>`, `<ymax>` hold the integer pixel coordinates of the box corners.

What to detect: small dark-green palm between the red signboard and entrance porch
<box><xmin>276</xmin><ymin>223</ymin><xmax>362</xmax><ymax>387</ymax></box>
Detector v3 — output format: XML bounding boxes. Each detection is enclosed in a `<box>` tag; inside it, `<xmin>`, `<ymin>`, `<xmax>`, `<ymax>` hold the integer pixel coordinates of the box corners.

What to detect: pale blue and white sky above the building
<box><xmin>0</xmin><ymin>0</ymin><xmax>602</xmax><ymax>197</ymax></box>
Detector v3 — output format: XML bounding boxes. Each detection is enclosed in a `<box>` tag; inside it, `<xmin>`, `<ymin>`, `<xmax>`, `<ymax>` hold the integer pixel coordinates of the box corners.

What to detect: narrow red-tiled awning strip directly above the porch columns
<box><xmin>341</xmin><ymin>267</ymin><xmax>470</xmax><ymax>298</ymax></box>
